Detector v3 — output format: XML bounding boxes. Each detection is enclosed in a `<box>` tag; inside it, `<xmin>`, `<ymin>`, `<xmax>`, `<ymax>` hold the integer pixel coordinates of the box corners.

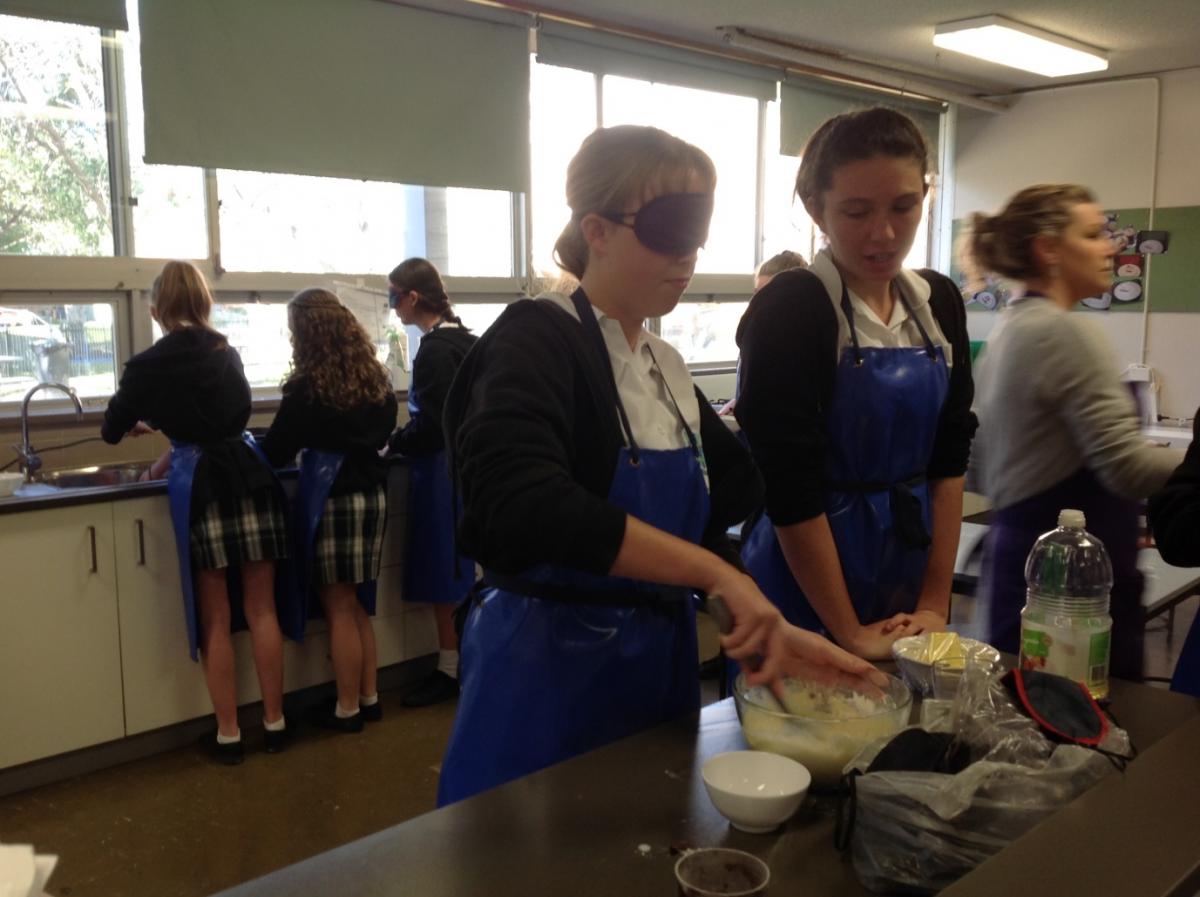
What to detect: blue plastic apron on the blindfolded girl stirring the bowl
<box><xmin>438</xmin><ymin>290</ymin><xmax>709</xmax><ymax>806</ymax></box>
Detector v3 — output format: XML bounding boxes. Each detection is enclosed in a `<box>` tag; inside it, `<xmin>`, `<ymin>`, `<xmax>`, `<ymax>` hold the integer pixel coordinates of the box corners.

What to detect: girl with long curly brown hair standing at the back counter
<box><xmin>263</xmin><ymin>289</ymin><xmax>396</xmax><ymax>732</ymax></box>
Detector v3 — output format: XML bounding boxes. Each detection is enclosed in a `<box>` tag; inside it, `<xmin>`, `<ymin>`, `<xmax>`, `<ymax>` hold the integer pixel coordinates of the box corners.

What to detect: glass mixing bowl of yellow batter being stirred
<box><xmin>733</xmin><ymin>674</ymin><xmax>912</xmax><ymax>791</ymax></box>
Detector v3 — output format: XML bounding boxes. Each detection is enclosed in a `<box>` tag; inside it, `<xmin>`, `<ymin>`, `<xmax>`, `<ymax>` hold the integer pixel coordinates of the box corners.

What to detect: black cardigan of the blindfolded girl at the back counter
<box><xmin>388</xmin><ymin>327</ymin><xmax>479</xmax><ymax>457</ymax></box>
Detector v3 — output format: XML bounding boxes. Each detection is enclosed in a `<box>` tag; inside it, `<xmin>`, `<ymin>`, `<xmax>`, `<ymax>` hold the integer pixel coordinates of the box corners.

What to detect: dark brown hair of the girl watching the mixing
<box><xmin>796</xmin><ymin>106</ymin><xmax>929</xmax><ymax>215</ymax></box>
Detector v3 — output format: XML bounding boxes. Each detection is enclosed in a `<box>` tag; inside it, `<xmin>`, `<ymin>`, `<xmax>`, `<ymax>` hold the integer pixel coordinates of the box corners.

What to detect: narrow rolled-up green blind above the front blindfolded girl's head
<box><xmin>538</xmin><ymin>23</ymin><xmax>781</xmax><ymax>100</ymax></box>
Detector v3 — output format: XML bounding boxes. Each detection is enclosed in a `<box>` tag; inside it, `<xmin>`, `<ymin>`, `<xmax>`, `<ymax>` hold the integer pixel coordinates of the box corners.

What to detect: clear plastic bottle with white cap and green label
<box><xmin>1021</xmin><ymin>510</ymin><xmax>1112</xmax><ymax>699</ymax></box>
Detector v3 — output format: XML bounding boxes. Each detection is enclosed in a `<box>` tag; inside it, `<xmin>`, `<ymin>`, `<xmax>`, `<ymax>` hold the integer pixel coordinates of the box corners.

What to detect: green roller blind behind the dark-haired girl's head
<box><xmin>779</xmin><ymin>78</ymin><xmax>941</xmax><ymax>170</ymax></box>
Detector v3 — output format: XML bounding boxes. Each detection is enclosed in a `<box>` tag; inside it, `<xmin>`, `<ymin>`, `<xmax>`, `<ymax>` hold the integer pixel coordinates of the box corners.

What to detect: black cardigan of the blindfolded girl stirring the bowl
<box><xmin>445</xmin><ymin>300</ymin><xmax>762</xmax><ymax>574</ymax></box>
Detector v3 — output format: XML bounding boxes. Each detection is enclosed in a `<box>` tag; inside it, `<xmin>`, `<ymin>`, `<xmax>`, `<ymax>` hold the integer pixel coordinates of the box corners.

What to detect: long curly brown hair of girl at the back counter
<box><xmin>284</xmin><ymin>287</ymin><xmax>391</xmax><ymax>410</ymax></box>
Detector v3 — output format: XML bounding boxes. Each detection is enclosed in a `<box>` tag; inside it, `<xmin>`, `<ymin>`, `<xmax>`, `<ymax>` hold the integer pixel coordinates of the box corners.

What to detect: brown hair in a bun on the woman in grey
<box><xmin>967</xmin><ymin>183</ymin><xmax>1096</xmax><ymax>281</ymax></box>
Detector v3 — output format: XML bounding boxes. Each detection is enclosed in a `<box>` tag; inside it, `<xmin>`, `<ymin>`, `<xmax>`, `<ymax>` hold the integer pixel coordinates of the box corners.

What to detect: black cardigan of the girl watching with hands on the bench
<box><xmin>734</xmin><ymin>270</ymin><xmax>978</xmax><ymax>526</ymax></box>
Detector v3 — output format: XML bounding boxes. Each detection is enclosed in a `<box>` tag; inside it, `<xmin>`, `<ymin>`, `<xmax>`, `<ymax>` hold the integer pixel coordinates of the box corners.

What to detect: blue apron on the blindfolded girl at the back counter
<box><xmin>403</xmin><ymin>391</ymin><xmax>475</xmax><ymax>604</ymax></box>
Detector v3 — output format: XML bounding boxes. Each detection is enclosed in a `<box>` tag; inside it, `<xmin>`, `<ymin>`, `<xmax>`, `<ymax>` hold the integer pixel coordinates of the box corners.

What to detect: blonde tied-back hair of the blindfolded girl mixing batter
<box><xmin>554</xmin><ymin>125</ymin><xmax>716</xmax><ymax>278</ymax></box>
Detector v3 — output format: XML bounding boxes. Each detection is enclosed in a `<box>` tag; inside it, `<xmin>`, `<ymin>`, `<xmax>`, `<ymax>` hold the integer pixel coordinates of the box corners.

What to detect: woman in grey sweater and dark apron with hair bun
<box><xmin>970</xmin><ymin>183</ymin><xmax>1182</xmax><ymax>679</ymax></box>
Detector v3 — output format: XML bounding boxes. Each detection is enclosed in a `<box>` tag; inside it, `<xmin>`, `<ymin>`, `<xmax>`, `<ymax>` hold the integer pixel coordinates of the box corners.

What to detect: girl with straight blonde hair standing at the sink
<box><xmin>101</xmin><ymin>261</ymin><xmax>302</xmax><ymax>765</ymax></box>
